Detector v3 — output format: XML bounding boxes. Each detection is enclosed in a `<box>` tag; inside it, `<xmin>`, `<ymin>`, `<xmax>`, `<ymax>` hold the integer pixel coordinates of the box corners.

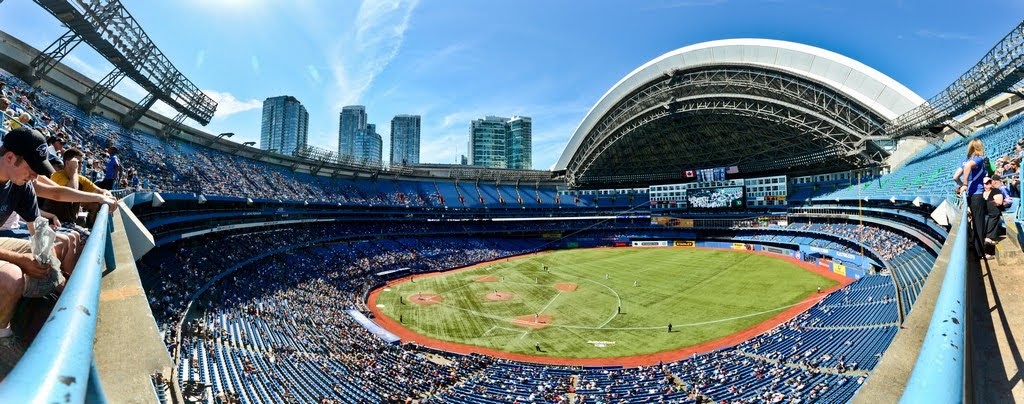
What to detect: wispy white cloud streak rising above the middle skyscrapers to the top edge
<box><xmin>328</xmin><ymin>0</ymin><xmax>418</xmax><ymax>110</ymax></box>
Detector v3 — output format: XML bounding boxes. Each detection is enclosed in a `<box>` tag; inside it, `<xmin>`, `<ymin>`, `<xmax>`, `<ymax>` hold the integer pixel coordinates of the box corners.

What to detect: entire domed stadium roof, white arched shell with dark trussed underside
<box><xmin>554</xmin><ymin>39</ymin><xmax>925</xmax><ymax>187</ymax></box>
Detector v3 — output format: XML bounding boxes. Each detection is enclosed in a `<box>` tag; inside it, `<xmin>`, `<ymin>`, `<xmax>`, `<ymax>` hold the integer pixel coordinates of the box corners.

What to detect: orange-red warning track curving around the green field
<box><xmin>367</xmin><ymin>249</ymin><xmax>853</xmax><ymax>367</ymax></box>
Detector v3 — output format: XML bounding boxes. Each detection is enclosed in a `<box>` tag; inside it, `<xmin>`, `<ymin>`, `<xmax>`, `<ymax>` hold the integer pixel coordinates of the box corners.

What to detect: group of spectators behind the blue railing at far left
<box><xmin>0</xmin><ymin>77</ymin><xmax>123</xmax><ymax>379</ymax></box>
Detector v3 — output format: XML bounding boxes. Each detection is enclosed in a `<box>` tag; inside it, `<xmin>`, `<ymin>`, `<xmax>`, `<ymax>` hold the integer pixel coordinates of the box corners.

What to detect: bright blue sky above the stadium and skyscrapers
<box><xmin>0</xmin><ymin>0</ymin><xmax>1024</xmax><ymax>169</ymax></box>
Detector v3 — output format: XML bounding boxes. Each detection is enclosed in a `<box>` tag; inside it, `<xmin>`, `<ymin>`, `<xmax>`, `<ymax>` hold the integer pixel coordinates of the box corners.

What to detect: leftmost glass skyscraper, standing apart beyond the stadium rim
<box><xmin>259</xmin><ymin>95</ymin><xmax>309</xmax><ymax>155</ymax></box>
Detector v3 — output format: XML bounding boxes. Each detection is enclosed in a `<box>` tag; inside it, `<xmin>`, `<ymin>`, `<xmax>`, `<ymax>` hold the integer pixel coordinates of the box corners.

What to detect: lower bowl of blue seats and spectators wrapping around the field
<box><xmin>151</xmin><ymin>226</ymin><xmax>895</xmax><ymax>403</ymax></box>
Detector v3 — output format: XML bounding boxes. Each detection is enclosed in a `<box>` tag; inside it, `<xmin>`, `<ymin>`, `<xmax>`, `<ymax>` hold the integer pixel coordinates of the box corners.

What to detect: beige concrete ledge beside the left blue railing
<box><xmin>93</xmin><ymin>208</ymin><xmax>173</xmax><ymax>403</ymax></box>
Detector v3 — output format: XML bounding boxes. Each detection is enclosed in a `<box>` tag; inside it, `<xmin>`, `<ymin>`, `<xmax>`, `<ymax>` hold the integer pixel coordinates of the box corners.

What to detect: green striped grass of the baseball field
<box><xmin>377</xmin><ymin>249</ymin><xmax>838</xmax><ymax>358</ymax></box>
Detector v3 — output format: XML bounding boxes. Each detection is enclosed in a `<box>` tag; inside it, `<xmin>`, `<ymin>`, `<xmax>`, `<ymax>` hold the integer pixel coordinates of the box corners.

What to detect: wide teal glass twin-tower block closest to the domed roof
<box><xmin>469</xmin><ymin>117</ymin><xmax>534</xmax><ymax>170</ymax></box>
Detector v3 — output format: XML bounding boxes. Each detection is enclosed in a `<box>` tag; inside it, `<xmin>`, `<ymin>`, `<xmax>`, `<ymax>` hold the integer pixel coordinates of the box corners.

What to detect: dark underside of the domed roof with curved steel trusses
<box><xmin>567</xmin><ymin>65</ymin><xmax>888</xmax><ymax>184</ymax></box>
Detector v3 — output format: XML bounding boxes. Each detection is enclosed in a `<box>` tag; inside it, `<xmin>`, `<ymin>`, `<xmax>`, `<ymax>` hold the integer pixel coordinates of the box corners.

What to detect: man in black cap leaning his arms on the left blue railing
<box><xmin>0</xmin><ymin>127</ymin><xmax>117</xmax><ymax>379</ymax></box>
